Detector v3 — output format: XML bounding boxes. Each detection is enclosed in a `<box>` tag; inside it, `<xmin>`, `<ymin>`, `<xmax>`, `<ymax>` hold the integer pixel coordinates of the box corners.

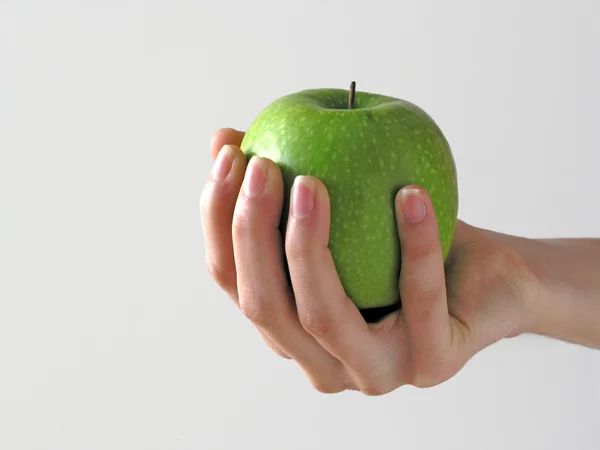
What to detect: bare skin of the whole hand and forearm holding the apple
<box><xmin>201</xmin><ymin>129</ymin><xmax>600</xmax><ymax>395</ymax></box>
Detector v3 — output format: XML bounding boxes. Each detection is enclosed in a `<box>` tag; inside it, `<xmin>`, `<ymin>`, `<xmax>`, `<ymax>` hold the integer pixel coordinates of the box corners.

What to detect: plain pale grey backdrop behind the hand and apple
<box><xmin>0</xmin><ymin>0</ymin><xmax>600</xmax><ymax>450</ymax></box>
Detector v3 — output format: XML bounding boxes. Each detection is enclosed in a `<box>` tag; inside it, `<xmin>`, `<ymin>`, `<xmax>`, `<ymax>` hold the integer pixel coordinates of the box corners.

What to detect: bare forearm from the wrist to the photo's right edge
<box><xmin>511</xmin><ymin>238</ymin><xmax>600</xmax><ymax>348</ymax></box>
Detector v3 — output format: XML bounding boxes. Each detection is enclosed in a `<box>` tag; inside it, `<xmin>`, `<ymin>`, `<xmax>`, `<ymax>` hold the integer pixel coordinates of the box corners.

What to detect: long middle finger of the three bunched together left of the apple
<box><xmin>233</xmin><ymin>157</ymin><xmax>347</xmax><ymax>392</ymax></box>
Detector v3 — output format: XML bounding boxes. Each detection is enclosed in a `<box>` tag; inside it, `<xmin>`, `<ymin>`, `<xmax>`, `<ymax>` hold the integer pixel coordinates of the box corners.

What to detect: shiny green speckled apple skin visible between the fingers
<box><xmin>241</xmin><ymin>89</ymin><xmax>458</xmax><ymax>310</ymax></box>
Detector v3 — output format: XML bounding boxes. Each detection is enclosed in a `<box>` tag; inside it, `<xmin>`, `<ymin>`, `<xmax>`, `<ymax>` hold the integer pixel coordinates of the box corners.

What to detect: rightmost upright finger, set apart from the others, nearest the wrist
<box><xmin>396</xmin><ymin>186</ymin><xmax>451</xmax><ymax>384</ymax></box>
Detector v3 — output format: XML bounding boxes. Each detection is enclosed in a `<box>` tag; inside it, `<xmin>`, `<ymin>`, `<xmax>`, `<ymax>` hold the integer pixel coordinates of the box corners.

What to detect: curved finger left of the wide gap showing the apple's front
<box><xmin>285</xmin><ymin>177</ymin><xmax>395</xmax><ymax>392</ymax></box>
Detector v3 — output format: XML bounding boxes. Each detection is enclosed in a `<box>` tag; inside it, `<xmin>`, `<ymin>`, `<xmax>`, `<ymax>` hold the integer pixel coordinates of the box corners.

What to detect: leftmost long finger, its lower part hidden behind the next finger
<box><xmin>200</xmin><ymin>145</ymin><xmax>246</xmax><ymax>301</ymax></box>
